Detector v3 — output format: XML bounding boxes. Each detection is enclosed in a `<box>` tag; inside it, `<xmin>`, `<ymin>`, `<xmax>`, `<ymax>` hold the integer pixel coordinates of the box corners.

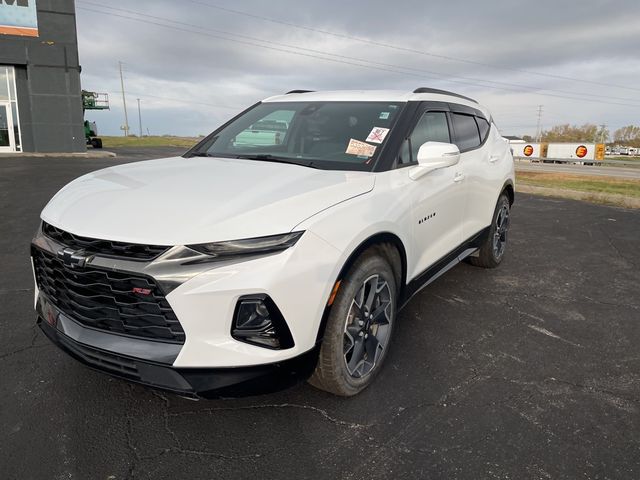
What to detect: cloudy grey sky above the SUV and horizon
<box><xmin>76</xmin><ymin>0</ymin><xmax>640</xmax><ymax>139</ymax></box>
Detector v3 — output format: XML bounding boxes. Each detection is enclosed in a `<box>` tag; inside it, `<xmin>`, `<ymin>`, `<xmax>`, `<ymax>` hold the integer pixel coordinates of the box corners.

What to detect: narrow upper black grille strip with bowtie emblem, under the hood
<box><xmin>42</xmin><ymin>222</ymin><xmax>169</xmax><ymax>260</ymax></box>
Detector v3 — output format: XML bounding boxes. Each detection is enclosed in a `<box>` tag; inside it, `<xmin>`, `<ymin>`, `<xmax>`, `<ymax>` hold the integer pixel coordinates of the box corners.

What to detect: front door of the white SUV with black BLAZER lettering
<box><xmin>400</xmin><ymin>103</ymin><xmax>465</xmax><ymax>279</ymax></box>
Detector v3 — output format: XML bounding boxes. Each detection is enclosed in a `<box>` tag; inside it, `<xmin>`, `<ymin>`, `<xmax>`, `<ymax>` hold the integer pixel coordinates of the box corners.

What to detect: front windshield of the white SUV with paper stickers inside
<box><xmin>189</xmin><ymin>102</ymin><xmax>404</xmax><ymax>170</ymax></box>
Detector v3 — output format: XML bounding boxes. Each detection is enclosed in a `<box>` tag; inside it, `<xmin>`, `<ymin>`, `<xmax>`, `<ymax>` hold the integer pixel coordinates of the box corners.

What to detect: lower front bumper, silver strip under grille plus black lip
<box><xmin>37</xmin><ymin>295</ymin><xmax>318</xmax><ymax>398</ymax></box>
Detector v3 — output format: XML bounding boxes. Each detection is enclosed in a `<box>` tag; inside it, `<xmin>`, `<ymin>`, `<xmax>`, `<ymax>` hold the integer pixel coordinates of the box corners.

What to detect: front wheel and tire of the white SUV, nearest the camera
<box><xmin>309</xmin><ymin>248</ymin><xmax>398</xmax><ymax>397</ymax></box>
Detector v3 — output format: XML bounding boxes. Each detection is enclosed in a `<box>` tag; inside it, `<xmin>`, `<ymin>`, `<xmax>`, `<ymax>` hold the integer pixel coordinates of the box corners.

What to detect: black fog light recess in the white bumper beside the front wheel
<box><xmin>231</xmin><ymin>295</ymin><xmax>293</xmax><ymax>349</ymax></box>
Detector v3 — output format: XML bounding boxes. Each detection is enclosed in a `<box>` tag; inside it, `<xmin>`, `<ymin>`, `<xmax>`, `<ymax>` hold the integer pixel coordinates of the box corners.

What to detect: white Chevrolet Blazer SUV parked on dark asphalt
<box><xmin>32</xmin><ymin>88</ymin><xmax>514</xmax><ymax>397</ymax></box>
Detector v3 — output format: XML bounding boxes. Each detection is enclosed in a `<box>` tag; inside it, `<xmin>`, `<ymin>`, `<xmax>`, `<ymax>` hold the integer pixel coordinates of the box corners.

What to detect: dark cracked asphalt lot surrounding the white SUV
<box><xmin>0</xmin><ymin>149</ymin><xmax>640</xmax><ymax>480</ymax></box>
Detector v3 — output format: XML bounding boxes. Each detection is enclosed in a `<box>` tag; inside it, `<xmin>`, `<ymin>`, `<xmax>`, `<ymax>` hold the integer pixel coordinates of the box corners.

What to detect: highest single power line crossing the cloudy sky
<box><xmin>181</xmin><ymin>0</ymin><xmax>640</xmax><ymax>91</ymax></box>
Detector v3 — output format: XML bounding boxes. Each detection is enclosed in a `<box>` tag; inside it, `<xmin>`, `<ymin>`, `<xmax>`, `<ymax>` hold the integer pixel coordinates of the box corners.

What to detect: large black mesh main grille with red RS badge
<box><xmin>31</xmin><ymin>247</ymin><xmax>185</xmax><ymax>343</ymax></box>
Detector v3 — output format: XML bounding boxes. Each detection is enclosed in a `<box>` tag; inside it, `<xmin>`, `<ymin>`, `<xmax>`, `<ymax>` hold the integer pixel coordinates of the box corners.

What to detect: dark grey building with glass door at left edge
<box><xmin>0</xmin><ymin>0</ymin><xmax>86</xmax><ymax>152</ymax></box>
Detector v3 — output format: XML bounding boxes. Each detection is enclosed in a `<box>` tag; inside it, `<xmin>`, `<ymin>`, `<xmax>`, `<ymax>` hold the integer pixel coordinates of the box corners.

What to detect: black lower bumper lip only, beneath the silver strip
<box><xmin>38</xmin><ymin>317</ymin><xmax>319</xmax><ymax>398</ymax></box>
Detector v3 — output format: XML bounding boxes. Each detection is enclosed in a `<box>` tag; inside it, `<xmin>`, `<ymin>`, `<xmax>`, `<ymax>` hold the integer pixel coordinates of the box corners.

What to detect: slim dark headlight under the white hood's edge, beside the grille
<box><xmin>187</xmin><ymin>232</ymin><xmax>304</xmax><ymax>259</ymax></box>
